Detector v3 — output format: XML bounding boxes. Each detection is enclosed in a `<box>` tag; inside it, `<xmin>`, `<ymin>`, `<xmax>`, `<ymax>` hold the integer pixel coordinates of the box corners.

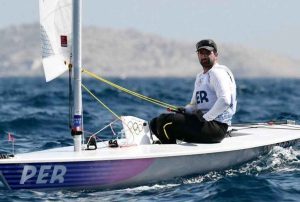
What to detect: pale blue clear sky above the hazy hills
<box><xmin>0</xmin><ymin>0</ymin><xmax>300</xmax><ymax>59</ymax></box>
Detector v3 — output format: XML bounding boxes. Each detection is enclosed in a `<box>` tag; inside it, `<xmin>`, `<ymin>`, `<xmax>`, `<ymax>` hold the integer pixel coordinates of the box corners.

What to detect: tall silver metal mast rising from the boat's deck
<box><xmin>71</xmin><ymin>0</ymin><xmax>83</xmax><ymax>152</ymax></box>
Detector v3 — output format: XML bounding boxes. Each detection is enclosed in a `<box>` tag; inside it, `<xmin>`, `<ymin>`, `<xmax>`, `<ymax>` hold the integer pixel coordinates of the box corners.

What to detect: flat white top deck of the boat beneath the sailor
<box><xmin>0</xmin><ymin>124</ymin><xmax>300</xmax><ymax>163</ymax></box>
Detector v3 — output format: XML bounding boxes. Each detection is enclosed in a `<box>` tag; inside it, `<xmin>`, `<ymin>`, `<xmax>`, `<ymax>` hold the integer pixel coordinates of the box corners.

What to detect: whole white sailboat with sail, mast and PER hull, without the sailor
<box><xmin>0</xmin><ymin>0</ymin><xmax>300</xmax><ymax>189</ymax></box>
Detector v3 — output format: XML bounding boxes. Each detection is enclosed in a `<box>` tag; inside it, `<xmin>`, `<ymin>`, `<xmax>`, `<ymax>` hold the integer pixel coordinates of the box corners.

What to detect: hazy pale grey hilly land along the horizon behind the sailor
<box><xmin>0</xmin><ymin>24</ymin><xmax>300</xmax><ymax>78</ymax></box>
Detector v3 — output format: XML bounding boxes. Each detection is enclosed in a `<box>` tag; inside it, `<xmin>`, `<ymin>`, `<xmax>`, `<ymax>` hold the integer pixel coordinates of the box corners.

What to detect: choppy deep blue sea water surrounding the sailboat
<box><xmin>0</xmin><ymin>77</ymin><xmax>300</xmax><ymax>202</ymax></box>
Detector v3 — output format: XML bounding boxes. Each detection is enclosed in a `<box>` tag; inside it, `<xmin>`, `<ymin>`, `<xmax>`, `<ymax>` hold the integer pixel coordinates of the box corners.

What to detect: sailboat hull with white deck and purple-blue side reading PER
<box><xmin>0</xmin><ymin>126</ymin><xmax>300</xmax><ymax>189</ymax></box>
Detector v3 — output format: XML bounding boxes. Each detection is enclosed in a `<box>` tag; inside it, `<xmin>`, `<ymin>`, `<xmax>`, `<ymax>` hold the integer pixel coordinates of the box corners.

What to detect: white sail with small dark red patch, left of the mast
<box><xmin>39</xmin><ymin>0</ymin><xmax>72</xmax><ymax>81</ymax></box>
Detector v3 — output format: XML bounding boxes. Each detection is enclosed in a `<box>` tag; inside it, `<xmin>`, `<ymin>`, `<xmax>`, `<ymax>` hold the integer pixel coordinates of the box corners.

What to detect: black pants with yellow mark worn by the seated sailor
<box><xmin>150</xmin><ymin>111</ymin><xmax>228</xmax><ymax>144</ymax></box>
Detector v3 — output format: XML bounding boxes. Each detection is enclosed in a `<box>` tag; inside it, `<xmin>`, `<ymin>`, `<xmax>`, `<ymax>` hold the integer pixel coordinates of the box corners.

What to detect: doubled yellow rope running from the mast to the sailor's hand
<box><xmin>82</xmin><ymin>69</ymin><xmax>177</xmax><ymax>110</ymax></box>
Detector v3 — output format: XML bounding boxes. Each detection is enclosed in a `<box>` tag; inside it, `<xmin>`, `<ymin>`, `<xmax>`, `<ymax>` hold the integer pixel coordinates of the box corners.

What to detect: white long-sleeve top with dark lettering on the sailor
<box><xmin>186</xmin><ymin>64</ymin><xmax>237</xmax><ymax>125</ymax></box>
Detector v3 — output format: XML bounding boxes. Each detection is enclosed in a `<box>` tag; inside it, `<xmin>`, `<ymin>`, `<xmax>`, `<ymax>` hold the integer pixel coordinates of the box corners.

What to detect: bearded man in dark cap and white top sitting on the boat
<box><xmin>150</xmin><ymin>39</ymin><xmax>237</xmax><ymax>144</ymax></box>
